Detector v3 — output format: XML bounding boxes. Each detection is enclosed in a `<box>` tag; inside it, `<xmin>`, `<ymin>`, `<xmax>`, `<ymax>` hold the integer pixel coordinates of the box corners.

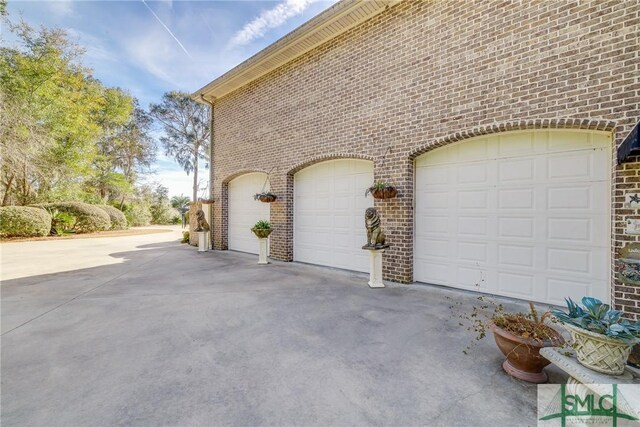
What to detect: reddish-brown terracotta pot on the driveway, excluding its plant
<box><xmin>491</xmin><ymin>324</ymin><xmax>564</xmax><ymax>384</ymax></box>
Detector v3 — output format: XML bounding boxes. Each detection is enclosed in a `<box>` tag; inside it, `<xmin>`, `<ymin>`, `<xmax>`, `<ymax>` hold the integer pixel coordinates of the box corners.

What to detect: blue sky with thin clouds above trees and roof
<box><xmin>3</xmin><ymin>0</ymin><xmax>337</xmax><ymax>196</ymax></box>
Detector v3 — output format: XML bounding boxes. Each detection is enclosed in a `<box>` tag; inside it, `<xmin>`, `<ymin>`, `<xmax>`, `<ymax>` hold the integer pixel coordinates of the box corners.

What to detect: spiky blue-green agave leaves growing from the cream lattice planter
<box><xmin>552</xmin><ymin>297</ymin><xmax>640</xmax><ymax>345</ymax></box>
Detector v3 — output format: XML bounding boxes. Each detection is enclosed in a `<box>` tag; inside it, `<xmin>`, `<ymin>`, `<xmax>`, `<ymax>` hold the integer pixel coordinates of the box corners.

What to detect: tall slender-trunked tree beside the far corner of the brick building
<box><xmin>149</xmin><ymin>91</ymin><xmax>210</xmax><ymax>201</ymax></box>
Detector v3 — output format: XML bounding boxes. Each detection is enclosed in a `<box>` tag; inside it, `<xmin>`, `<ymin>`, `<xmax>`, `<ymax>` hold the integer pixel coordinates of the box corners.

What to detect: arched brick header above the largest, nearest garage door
<box><xmin>409</xmin><ymin>118</ymin><xmax>616</xmax><ymax>160</ymax></box>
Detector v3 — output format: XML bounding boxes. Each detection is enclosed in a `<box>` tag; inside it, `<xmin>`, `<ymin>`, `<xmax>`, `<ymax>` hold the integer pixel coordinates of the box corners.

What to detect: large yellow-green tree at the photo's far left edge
<box><xmin>0</xmin><ymin>23</ymin><xmax>103</xmax><ymax>204</ymax></box>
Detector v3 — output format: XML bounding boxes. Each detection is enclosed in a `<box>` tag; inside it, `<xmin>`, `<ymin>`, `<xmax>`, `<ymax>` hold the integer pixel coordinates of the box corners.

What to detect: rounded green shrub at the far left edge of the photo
<box><xmin>0</xmin><ymin>206</ymin><xmax>51</xmax><ymax>237</ymax></box>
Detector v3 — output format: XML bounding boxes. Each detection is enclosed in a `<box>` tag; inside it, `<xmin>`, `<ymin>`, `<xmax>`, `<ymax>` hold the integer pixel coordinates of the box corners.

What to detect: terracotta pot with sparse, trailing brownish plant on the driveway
<box><xmin>452</xmin><ymin>296</ymin><xmax>564</xmax><ymax>383</ymax></box>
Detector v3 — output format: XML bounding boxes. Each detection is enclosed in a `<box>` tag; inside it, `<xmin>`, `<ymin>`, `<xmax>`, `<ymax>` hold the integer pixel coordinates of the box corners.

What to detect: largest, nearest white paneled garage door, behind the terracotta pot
<box><xmin>414</xmin><ymin>130</ymin><xmax>611</xmax><ymax>304</ymax></box>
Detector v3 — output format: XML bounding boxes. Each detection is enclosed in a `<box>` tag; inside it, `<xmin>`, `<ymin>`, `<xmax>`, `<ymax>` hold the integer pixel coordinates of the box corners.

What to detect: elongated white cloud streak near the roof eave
<box><xmin>230</xmin><ymin>0</ymin><xmax>317</xmax><ymax>46</ymax></box>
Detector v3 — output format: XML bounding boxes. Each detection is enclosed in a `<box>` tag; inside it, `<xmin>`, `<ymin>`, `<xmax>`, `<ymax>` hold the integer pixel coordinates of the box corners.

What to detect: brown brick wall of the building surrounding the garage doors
<box><xmin>212</xmin><ymin>0</ymin><xmax>640</xmax><ymax>313</ymax></box>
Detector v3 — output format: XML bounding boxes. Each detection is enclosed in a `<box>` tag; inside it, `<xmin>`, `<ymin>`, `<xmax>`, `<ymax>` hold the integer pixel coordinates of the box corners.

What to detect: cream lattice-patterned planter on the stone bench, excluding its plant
<box><xmin>564</xmin><ymin>323</ymin><xmax>631</xmax><ymax>375</ymax></box>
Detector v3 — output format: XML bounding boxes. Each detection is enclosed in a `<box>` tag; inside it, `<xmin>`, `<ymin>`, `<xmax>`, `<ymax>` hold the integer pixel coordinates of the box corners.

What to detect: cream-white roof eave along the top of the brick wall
<box><xmin>191</xmin><ymin>0</ymin><xmax>402</xmax><ymax>102</ymax></box>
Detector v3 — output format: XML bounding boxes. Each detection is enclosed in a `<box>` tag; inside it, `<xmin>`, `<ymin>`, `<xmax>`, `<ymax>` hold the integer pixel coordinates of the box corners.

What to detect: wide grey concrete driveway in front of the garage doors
<box><xmin>0</xmin><ymin>231</ymin><xmax>564</xmax><ymax>426</ymax></box>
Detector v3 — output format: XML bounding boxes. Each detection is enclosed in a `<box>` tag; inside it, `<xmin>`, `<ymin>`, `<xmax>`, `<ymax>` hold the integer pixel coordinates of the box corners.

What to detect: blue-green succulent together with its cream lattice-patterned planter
<box><xmin>553</xmin><ymin>297</ymin><xmax>640</xmax><ymax>375</ymax></box>
